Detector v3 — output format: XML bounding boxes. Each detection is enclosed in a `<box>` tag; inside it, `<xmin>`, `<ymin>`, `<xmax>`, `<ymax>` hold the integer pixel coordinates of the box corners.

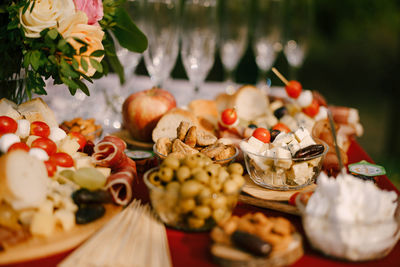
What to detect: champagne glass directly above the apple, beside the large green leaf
<box><xmin>139</xmin><ymin>0</ymin><xmax>180</xmax><ymax>87</ymax></box>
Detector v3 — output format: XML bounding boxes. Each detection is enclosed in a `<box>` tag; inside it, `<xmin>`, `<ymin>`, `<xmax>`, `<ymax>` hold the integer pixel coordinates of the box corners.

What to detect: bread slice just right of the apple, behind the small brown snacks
<box><xmin>152</xmin><ymin>108</ymin><xmax>199</xmax><ymax>143</ymax></box>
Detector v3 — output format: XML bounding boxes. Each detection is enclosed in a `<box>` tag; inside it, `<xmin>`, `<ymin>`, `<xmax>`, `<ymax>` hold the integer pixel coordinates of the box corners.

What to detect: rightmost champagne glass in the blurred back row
<box><xmin>283</xmin><ymin>0</ymin><xmax>312</xmax><ymax>79</ymax></box>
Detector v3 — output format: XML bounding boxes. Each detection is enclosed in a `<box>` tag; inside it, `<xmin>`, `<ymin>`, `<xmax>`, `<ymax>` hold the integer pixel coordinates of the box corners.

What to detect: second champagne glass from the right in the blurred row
<box><xmin>253</xmin><ymin>0</ymin><xmax>283</xmax><ymax>90</ymax></box>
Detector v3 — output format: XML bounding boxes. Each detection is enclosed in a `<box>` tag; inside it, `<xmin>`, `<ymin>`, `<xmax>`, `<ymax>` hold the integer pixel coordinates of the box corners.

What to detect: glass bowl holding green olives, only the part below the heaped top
<box><xmin>143</xmin><ymin>166</ymin><xmax>244</xmax><ymax>232</ymax></box>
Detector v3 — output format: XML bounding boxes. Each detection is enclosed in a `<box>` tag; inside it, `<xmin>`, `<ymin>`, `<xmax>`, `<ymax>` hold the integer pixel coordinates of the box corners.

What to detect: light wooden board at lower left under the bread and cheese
<box><xmin>0</xmin><ymin>204</ymin><xmax>122</xmax><ymax>264</ymax></box>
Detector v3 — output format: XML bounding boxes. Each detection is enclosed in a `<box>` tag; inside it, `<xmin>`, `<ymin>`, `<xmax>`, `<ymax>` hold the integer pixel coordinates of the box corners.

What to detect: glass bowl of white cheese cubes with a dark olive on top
<box><xmin>241</xmin><ymin>138</ymin><xmax>329</xmax><ymax>191</ymax></box>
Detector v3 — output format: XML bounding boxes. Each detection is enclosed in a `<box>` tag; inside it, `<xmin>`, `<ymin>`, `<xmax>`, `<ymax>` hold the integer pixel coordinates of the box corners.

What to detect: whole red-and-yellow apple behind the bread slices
<box><xmin>122</xmin><ymin>88</ymin><xmax>176</xmax><ymax>141</ymax></box>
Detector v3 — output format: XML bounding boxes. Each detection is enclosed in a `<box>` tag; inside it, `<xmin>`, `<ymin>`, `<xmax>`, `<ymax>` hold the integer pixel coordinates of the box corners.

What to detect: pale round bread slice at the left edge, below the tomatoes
<box><xmin>0</xmin><ymin>150</ymin><xmax>48</xmax><ymax>210</ymax></box>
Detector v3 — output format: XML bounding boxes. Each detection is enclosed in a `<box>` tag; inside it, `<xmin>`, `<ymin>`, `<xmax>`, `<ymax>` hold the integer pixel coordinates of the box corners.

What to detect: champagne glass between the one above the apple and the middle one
<box><xmin>181</xmin><ymin>0</ymin><xmax>218</xmax><ymax>93</ymax></box>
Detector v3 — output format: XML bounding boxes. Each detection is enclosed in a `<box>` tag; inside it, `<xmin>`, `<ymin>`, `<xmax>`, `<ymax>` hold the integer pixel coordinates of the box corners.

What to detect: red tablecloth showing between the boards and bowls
<box><xmin>3</xmin><ymin>142</ymin><xmax>400</xmax><ymax>267</ymax></box>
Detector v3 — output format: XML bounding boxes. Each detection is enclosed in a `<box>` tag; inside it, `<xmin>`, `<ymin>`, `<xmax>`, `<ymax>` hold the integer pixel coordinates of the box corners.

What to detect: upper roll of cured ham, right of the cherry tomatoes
<box><xmin>92</xmin><ymin>135</ymin><xmax>126</xmax><ymax>169</ymax></box>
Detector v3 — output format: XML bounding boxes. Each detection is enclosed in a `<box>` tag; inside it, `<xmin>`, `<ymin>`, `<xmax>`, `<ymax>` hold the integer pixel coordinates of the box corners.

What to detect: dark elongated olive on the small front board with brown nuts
<box><xmin>231</xmin><ymin>231</ymin><xmax>272</xmax><ymax>256</ymax></box>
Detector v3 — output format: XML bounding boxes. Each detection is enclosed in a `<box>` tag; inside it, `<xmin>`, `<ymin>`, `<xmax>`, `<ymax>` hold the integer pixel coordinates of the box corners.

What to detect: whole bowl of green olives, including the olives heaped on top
<box><xmin>143</xmin><ymin>153</ymin><xmax>245</xmax><ymax>231</ymax></box>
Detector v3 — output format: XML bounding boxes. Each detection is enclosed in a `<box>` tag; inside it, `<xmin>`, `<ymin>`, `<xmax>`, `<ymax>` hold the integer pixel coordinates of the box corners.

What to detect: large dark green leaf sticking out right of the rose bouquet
<box><xmin>113</xmin><ymin>7</ymin><xmax>147</xmax><ymax>53</ymax></box>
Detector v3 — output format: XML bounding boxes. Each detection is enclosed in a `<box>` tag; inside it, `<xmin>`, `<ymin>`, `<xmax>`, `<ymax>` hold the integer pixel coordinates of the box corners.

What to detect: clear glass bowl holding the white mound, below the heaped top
<box><xmin>296</xmin><ymin>192</ymin><xmax>400</xmax><ymax>261</ymax></box>
